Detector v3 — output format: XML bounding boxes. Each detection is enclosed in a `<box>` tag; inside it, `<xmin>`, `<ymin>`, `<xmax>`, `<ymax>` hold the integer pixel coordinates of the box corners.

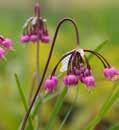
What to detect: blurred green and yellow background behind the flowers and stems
<box><xmin>0</xmin><ymin>0</ymin><xmax>119</xmax><ymax>130</ymax></box>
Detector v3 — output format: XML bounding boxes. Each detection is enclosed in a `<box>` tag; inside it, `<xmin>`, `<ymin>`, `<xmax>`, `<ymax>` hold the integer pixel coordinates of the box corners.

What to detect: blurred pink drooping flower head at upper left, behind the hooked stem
<box><xmin>21</xmin><ymin>3</ymin><xmax>50</xmax><ymax>44</ymax></box>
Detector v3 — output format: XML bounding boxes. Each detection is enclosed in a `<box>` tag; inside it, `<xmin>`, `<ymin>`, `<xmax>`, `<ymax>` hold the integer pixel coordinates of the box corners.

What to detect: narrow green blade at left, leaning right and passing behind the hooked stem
<box><xmin>14</xmin><ymin>74</ymin><xmax>34</xmax><ymax>130</ymax></box>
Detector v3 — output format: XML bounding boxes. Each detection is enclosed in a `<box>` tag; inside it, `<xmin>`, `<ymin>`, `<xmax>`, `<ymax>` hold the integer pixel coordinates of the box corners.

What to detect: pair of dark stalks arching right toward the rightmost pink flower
<box><xmin>84</xmin><ymin>49</ymin><xmax>110</xmax><ymax>68</ymax></box>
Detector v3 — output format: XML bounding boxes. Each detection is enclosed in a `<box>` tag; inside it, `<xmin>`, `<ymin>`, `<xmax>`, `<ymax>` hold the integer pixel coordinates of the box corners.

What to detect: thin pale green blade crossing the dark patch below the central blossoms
<box><xmin>58</xmin><ymin>86</ymin><xmax>79</xmax><ymax>130</ymax></box>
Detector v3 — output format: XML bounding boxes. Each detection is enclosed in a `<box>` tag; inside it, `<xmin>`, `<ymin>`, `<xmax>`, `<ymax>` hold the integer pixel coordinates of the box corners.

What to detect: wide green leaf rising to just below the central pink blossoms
<box><xmin>45</xmin><ymin>87</ymin><xmax>67</xmax><ymax>130</ymax></box>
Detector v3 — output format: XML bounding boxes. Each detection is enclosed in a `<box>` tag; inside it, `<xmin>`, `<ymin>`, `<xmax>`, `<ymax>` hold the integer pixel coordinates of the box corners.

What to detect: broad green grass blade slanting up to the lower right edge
<box><xmin>85</xmin><ymin>83</ymin><xmax>119</xmax><ymax>130</ymax></box>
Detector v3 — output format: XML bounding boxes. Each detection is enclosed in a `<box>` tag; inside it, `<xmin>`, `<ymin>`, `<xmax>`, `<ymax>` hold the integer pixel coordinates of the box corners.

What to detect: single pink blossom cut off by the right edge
<box><xmin>103</xmin><ymin>67</ymin><xmax>119</xmax><ymax>80</ymax></box>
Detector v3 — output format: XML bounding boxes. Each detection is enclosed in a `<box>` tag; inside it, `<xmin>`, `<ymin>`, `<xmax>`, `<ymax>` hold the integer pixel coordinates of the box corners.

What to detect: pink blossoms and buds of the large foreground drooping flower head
<box><xmin>45</xmin><ymin>51</ymin><xmax>119</xmax><ymax>92</ymax></box>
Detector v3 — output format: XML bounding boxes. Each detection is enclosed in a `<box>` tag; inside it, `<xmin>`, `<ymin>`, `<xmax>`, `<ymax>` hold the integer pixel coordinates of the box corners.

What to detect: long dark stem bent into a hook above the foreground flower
<box><xmin>21</xmin><ymin>18</ymin><xmax>79</xmax><ymax>130</ymax></box>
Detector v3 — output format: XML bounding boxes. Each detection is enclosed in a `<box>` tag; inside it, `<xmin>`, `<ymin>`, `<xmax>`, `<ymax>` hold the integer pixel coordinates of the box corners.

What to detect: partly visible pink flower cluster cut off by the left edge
<box><xmin>0</xmin><ymin>35</ymin><xmax>13</xmax><ymax>59</ymax></box>
